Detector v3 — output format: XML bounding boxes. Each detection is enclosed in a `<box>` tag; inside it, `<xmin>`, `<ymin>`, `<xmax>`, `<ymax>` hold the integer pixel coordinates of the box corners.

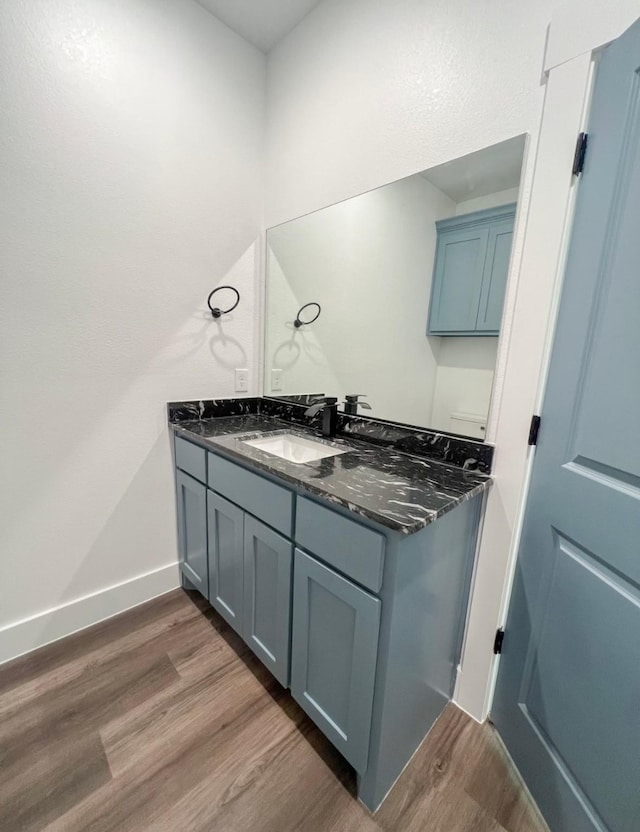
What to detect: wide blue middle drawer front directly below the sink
<box><xmin>208</xmin><ymin>453</ymin><xmax>294</xmax><ymax>538</ymax></box>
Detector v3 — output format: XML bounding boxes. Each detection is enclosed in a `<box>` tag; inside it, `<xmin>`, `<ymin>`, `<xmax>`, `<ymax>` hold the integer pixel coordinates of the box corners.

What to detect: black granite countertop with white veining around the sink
<box><xmin>171</xmin><ymin>414</ymin><xmax>492</xmax><ymax>534</ymax></box>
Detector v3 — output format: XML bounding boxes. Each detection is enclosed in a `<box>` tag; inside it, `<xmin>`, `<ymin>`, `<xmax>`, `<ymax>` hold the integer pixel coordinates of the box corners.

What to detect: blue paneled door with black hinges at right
<box><xmin>492</xmin><ymin>21</ymin><xmax>640</xmax><ymax>832</ymax></box>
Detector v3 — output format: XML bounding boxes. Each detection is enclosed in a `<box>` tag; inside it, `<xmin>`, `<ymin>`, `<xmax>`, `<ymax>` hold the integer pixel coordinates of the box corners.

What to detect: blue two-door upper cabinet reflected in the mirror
<box><xmin>428</xmin><ymin>203</ymin><xmax>516</xmax><ymax>335</ymax></box>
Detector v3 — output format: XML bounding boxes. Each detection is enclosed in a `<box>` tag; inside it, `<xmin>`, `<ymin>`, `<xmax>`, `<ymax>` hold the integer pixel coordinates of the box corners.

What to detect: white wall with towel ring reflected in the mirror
<box><xmin>265</xmin><ymin>175</ymin><xmax>455</xmax><ymax>425</ymax></box>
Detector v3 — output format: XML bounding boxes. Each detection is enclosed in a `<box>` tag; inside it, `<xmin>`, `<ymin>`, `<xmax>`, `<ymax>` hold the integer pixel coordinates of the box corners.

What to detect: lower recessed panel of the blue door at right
<box><xmin>522</xmin><ymin>534</ymin><xmax>640</xmax><ymax>828</ymax></box>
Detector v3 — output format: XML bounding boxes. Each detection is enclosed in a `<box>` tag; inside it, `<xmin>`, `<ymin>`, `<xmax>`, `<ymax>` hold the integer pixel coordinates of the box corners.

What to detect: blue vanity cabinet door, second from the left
<box><xmin>207</xmin><ymin>491</ymin><xmax>244</xmax><ymax>635</ymax></box>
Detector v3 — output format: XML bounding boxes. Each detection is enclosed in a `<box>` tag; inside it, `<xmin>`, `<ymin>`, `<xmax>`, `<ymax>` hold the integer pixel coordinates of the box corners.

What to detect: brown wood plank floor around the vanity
<box><xmin>0</xmin><ymin>590</ymin><xmax>544</xmax><ymax>832</ymax></box>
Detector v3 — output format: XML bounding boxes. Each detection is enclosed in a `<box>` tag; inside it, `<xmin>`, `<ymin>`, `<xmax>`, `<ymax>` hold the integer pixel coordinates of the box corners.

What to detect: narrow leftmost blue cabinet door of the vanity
<box><xmin>176</xmin><ymin>471</ymin><xmax>209</xmax><ymax>598</ymax></box>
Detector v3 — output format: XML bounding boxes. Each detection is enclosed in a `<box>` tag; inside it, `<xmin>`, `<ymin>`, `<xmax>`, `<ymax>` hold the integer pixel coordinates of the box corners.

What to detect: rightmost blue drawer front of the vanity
<box><xmin>295</xmin><ymin>497</ymin><xmax>386</xmax><ymax>592</ymax></box>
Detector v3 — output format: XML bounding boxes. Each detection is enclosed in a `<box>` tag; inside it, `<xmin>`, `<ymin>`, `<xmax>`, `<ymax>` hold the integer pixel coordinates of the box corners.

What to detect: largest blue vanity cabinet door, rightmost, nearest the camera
<box><xmin>291</xmin><ymin>549</ymin><xmax>381</xmax><ymax>772</ymax></box>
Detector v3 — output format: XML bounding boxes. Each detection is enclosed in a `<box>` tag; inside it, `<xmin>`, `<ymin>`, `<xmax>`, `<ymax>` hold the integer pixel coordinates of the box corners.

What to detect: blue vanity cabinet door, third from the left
<box><xmin>244</xmin><ymin>514</ymin><xmax>293</xmax><ymax>687</ymax></box>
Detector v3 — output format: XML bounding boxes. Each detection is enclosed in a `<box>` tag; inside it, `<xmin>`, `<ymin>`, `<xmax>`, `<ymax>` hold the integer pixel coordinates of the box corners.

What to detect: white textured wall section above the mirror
<box><xmin>266</xmin><ymin>0</ymin><xmax>551</xmax><ymax>226</ymax></box>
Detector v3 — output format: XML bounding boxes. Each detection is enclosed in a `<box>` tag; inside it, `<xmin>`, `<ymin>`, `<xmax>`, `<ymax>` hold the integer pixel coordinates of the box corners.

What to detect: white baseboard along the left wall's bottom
<box><xmin>0</xmin><ymin>563</ymin><xmax>180</xmax><ymax>664</ymax></box>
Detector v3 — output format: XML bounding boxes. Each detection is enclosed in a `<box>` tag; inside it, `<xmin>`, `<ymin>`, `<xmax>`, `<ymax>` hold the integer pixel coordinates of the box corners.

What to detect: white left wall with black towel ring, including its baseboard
<box><xmin>0</xmin><ymin>0</ymin><xmax>265</xmax><ymax>660</ymax></box>
